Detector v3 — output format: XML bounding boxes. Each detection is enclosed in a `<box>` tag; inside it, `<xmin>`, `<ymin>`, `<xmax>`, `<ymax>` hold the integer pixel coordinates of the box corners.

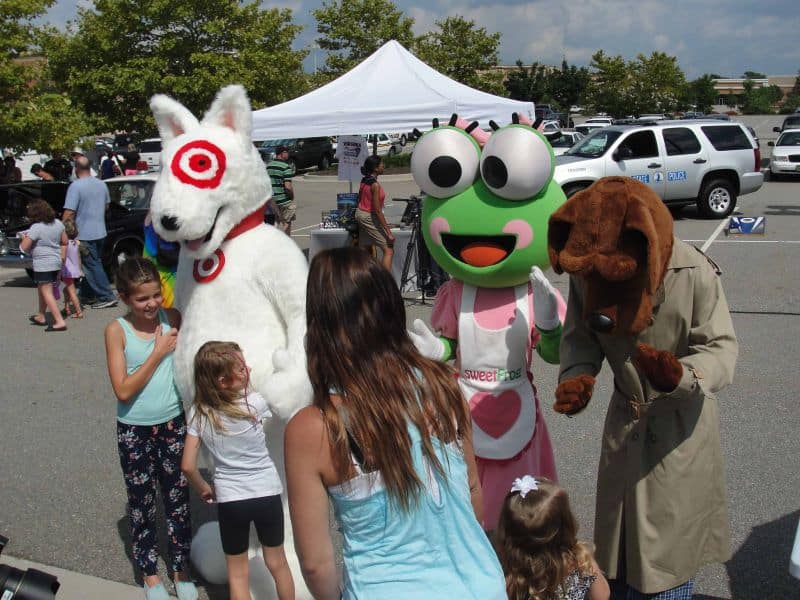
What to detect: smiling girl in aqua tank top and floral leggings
<box><xmin>105</xmin><ymin>258</ymin><xmax>197</xmax><ymax>600</ymax></box>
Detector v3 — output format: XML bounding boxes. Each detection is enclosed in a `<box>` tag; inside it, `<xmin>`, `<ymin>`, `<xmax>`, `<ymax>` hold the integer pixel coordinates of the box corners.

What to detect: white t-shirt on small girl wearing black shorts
<box><xmin>186</xmin><ymin>392</ymin><xmax>283</xmax><ymax>502</ymax></box>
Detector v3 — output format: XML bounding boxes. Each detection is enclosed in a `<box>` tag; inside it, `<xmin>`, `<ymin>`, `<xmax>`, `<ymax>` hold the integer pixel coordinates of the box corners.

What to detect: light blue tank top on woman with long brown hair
<box><xmin>328</xmin><ymin>425</ymin><xmax>506</xmax><ymax>600</ymax></box>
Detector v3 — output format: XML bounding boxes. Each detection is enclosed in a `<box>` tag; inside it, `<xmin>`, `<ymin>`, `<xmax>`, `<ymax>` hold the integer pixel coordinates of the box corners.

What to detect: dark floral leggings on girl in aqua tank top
<box><xmin>117</xmin><ymin>415</ymin><xmax>192</xmax><ymax>575</ymax></box>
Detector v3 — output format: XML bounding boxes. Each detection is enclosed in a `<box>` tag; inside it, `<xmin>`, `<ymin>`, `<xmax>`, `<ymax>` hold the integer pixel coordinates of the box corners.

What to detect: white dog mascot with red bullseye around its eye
<box><xmin>150</xmin><ymin>85</ymin><xmax>311</xmax><ymax>598</ymax></box>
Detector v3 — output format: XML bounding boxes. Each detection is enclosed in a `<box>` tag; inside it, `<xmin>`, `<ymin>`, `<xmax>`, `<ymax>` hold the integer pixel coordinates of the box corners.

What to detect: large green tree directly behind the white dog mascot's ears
<box><xmin>48</xmin><ymin>0</ymin><xmax>307</xmax><ymax>132</ymax></box>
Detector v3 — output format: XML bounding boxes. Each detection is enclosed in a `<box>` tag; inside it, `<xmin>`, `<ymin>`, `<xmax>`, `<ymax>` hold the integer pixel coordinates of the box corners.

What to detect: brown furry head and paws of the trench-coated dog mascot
<box><xmin>548</xmin><ymin>177</ymin><xmax>683</xmax><ymax>414</ymax></box>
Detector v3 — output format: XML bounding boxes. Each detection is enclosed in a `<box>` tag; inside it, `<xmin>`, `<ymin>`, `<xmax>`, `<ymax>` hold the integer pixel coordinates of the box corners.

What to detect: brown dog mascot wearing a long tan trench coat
<box><xmin>548</xmin><ymin>177</ymin><xmax>738</xmax><ymax>598</ymax></box>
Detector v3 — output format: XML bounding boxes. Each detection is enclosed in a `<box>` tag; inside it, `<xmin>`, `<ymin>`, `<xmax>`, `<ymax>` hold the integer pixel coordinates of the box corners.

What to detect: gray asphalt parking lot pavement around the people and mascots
<box><xmin>0</xmin><ymin>174</ymin><xmax>800</xmax><ymax>600</ymax></box>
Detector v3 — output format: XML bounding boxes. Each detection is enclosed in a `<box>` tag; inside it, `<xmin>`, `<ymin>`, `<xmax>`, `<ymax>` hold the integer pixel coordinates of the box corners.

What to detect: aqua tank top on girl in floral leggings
<box><xmin>117</xmin><ymin>309</ymin><xmax>183</xmax><ymax>425</ymax></box>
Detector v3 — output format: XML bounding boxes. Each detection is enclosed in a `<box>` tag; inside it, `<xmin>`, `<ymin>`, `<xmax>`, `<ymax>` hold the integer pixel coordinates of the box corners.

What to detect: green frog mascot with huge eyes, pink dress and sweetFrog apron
<box><xmin>409</xmin><ymin>115</ymin><xmax>566</xmax><ymax>530</ymax></box>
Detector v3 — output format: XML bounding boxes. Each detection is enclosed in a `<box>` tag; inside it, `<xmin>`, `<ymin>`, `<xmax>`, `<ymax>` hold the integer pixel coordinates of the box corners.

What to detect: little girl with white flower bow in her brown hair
<box><xmin>497</xmin><ymin>475</ymin><xmax>611</xmax><ymax>600</ymax></box>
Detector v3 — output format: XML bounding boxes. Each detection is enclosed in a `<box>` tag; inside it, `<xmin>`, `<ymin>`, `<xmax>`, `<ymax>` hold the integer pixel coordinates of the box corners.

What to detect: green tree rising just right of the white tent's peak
<box><xmin>416</xmin><ymin>16</ymin><xmax>504</xmax><ymax>94</ymax></box>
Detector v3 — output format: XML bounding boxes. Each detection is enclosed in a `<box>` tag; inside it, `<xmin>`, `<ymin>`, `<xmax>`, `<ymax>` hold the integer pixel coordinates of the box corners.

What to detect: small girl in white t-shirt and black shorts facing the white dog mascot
<box><xmin>181</xmin><ymin>341</ymin><xmax>294</xmax><ymax>600</ymax></box>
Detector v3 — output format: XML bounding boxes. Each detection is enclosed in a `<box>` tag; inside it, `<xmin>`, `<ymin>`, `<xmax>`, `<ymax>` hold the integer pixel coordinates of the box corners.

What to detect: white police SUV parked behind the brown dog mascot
<box><xmin>554</xmin><ymin>119</ymin><xmax>764</xmax><ymax>218</ymax></box>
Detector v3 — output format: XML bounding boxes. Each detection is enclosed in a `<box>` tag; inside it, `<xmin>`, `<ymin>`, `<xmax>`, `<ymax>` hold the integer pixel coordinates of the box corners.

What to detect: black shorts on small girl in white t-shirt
<box><xmin>217</xmin><ymin>494</ymin><xmax>283</xmax><ymax>555</ymax></box>
